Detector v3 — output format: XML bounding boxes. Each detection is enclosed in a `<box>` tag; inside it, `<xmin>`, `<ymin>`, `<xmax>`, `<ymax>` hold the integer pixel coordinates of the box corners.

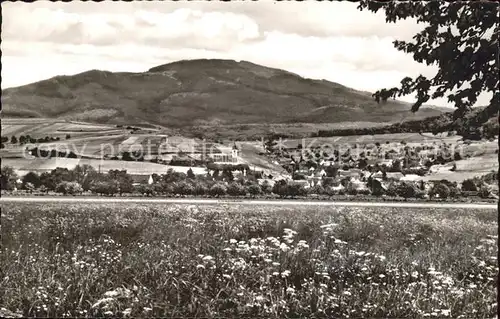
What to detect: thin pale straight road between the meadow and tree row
<box><xmin>0</xmin><ymin>197</ymin><xmax>498</xmax><ymax>210</ymax></box>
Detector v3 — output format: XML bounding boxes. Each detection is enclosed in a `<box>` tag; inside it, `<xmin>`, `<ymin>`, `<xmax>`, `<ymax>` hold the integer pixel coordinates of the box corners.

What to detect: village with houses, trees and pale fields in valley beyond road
<box><xmin>2</xmin><ymin>131</ymin><xmax>498</xmax><ymax>199</ymax></box>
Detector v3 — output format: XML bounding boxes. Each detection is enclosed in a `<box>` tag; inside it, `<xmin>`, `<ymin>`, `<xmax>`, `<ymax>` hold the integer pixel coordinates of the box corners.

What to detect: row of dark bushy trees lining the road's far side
<box><xmin>1</xmin><ymin>165</ymin><xmax>491</xmax><ymax>199</ymax></box>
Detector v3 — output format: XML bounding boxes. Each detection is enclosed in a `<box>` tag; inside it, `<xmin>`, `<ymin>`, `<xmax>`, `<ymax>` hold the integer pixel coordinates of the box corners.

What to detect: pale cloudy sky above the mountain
<box><xmin>1</xmin><ymin>0</ymin><xmax>489</xmax><ymax>106</ymax></box>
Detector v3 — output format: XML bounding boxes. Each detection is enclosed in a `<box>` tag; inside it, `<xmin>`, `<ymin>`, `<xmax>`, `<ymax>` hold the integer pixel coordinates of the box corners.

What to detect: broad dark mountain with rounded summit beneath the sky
<box><xmin>2</xmin><ymin>60</ymin><xmax>441</xmax><ymax>127</ymax></box>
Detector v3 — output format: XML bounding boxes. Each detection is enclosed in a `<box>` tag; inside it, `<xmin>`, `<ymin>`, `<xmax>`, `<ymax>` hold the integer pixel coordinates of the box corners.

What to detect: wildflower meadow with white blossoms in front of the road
<box><xmin>0</xmin><ymin>203</ymin><xmax>498</xmax><ymax>318</ymax></box>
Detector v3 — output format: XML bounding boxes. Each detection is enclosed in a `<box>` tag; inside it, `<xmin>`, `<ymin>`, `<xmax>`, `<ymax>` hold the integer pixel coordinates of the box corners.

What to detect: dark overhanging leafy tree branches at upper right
<box><xmin>358</xmin><ymin>1</ymin><xmax>500</xmax><ymax>117</ymax></box>
